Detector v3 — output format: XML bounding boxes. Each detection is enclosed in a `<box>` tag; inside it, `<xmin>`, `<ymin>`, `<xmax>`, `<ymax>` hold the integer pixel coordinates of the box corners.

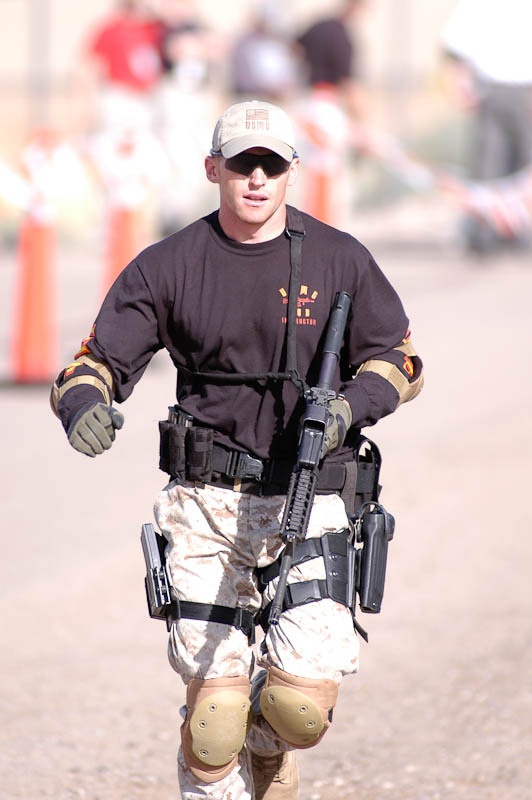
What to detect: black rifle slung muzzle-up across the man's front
<box><xmin>268</xmin><ymin>292</ymin><xmax>351</xmax><ymax>625</ymax></box>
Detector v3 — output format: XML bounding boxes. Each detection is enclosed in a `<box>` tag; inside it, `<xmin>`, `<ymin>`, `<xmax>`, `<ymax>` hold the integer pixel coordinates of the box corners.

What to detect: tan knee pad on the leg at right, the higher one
<box><xmin>260</xmin><ymin>667</ymin><xmax>338</xmax><ymax>749</ymax></box>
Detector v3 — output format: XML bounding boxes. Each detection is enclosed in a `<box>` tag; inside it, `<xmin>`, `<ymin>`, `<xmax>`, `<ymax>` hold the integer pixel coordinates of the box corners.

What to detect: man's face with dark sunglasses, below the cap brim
<box><xmin>205</xmin><ymin>147</ymin><xmax>299</xmax><ymax>233</ymax></box>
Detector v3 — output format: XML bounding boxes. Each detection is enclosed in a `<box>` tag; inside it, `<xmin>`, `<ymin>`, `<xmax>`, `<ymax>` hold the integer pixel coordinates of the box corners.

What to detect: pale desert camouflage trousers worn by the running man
<box><xmin>154</xmin><ymin>481</ymin><xmax>359</xmax><ymax>800</ymax></box>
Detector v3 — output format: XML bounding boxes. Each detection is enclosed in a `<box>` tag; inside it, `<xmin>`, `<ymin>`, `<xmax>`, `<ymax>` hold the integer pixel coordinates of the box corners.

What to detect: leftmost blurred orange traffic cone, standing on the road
<box><xmin>11</xmin><ymin>213</ymin><xmax>59</xmax><ymax>383</ymax></box>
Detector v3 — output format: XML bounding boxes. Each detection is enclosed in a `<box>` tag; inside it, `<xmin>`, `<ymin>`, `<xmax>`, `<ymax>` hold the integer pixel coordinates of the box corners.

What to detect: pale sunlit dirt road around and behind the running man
<box><xmin>0</xmin><ymin>227</ymin><xmax>532</xmax><ymax>800</ymax></box>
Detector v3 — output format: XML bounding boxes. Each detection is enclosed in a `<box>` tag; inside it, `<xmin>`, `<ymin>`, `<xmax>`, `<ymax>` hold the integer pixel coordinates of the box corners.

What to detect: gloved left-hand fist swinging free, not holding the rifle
<box><xmin>67</xmin><ymin>403</ymin><xmax>124</xmax><ymax>458</ymax></box>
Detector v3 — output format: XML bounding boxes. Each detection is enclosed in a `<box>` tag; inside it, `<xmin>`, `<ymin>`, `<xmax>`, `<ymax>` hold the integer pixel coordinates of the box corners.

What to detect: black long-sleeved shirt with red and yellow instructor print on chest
<box><xmin>80</xmin><ymin>212</ymin><xmax>408</xmax><ymax>458</ymax></box>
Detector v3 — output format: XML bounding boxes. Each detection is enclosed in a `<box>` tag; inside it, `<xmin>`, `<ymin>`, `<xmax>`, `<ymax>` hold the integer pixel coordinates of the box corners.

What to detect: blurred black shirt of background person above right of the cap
<box><xmin>298</xmin><ymin>19</ymin><xmax>356</xmax><ymax>86</ymax></box>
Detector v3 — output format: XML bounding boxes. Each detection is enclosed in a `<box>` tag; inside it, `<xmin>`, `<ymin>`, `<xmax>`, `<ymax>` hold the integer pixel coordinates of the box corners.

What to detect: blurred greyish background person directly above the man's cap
<box><xmin>228</xmin><ymin>0</ymin><xmax>301</xmax><ymax>105</ymax></box>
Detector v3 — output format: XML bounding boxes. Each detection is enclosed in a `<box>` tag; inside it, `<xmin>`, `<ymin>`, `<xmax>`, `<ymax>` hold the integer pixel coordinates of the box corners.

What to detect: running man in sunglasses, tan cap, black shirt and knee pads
<box><xmin>51</xmin><ymin>101</ymin><xmax>423</xmax><ymax>800</ymax></box>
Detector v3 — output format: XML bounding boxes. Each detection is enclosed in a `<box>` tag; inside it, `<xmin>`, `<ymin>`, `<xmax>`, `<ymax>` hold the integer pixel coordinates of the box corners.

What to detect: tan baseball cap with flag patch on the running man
<box><xmin>211</xmin><ymin>100</ymin><xmax>295</xmax><ymax>161</ymax></box>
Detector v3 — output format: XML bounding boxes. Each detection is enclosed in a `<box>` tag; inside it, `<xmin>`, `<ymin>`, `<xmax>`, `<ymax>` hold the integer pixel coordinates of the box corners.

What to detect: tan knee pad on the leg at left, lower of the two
<box><xmin>181</xmin><ymin>677</ymin><xmax>250</xmax><ymax>783</ymax></box>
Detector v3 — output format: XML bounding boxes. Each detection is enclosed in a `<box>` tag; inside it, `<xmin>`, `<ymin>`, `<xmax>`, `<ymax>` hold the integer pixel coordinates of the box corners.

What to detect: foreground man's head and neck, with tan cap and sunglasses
<box><xmin>205</xmin><ymin>100</ymin><xmax>299</xmax><ymax>242</ymax></box>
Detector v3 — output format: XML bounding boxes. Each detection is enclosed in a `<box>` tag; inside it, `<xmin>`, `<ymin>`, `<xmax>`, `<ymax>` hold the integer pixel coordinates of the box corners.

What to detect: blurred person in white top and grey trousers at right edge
<box><xmin>441</xmin><ymin>0</ymin><xmax>532</xmax><ymax>254</ymax></box>
